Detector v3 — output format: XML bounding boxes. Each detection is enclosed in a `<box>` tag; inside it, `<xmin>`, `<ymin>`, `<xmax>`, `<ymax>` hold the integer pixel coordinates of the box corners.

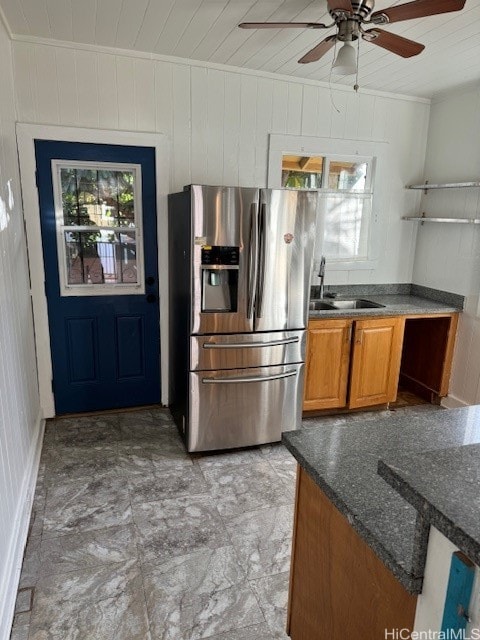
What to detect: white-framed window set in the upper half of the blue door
<box><xmin>52</xmin><ymin>160</ymin><xmax>143</xmax><ymax>295</ymax></box>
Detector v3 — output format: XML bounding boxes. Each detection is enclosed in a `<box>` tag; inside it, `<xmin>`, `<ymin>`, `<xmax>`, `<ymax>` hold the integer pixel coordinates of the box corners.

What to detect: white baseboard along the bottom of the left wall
<box><xmin>0</xmin><ymin>412</ymin><xmax>45</xmax><ymax>640</ymax></box>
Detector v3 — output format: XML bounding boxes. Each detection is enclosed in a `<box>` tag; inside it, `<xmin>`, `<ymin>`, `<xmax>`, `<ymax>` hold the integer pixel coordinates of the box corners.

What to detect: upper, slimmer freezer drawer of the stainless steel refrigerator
<box><xmin>190</xmin><ymin>330</ymin><xmax>306</xmax><ymax>371</ymax></box>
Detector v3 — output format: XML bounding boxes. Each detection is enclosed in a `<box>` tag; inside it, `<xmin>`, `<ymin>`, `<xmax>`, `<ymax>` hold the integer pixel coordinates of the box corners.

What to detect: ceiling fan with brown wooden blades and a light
<box><xmin>238</xmin><ymin>0</ymin><xmax>466</xmax><ymax>66</ymax></box>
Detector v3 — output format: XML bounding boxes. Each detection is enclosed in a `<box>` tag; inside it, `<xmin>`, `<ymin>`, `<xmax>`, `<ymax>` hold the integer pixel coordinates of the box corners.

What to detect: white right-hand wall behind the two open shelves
<box><xmin>408</xmin><ymin>87</ymin><xmax>480</xmax><ymax>404</ymax></box>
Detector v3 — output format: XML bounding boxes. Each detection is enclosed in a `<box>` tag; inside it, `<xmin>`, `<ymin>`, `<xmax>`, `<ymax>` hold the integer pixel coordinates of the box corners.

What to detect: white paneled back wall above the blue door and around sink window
<box><xmin>13</xmin><ymin>41</ymin><xmax>430</xmax><ymax>284</ymax></box>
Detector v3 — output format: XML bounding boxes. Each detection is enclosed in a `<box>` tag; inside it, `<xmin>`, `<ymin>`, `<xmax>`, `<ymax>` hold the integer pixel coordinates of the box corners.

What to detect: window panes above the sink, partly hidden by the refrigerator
<box><xmin>282</xmin><ymin>154</ymin><xmax>373</xmax><ymax>262</ymax></box>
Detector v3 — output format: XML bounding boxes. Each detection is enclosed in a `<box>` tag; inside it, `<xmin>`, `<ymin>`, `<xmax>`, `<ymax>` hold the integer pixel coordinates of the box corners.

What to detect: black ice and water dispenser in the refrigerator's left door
<box><xmin>201</xmin><ymin>245</ymin><xmax>240</xmax><ymax>313</ymax></box>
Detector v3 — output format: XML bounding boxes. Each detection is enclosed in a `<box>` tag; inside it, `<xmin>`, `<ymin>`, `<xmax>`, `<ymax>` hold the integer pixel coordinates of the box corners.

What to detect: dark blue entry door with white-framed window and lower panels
<box><xmin>35</xmin><ymin>140</ymin><xmax>160</xmax><ymax>415</ymax></box>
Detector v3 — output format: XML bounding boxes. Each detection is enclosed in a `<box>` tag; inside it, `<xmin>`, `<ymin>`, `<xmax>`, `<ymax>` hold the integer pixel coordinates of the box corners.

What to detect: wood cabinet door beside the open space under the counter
<box><xmin>348</xmin><ymin>318</ymin><xmax>405</xmax><ymax>409</ymax></box>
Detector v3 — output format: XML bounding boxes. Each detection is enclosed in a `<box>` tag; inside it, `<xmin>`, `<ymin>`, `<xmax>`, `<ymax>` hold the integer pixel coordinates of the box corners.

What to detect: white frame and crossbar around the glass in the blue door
<box><xmin>52</xmin><ymin>160</ymin><xmax>145</xmax><ymax>297</ymax></box>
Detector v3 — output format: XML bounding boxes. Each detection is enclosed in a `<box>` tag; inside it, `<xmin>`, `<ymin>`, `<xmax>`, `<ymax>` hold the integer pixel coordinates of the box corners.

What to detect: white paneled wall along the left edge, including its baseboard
<box><xmin>0</xmin><ymin>13</ymin><xmax>42</xmax><ymax>640</ymax></box>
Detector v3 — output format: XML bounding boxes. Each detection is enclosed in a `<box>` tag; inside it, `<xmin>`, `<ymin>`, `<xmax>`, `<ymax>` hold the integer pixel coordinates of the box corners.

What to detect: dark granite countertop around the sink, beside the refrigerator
<box><xmin>309</xmin><ymin>284</ymin><xmax>464</xmax><ymax>319</ymax></box>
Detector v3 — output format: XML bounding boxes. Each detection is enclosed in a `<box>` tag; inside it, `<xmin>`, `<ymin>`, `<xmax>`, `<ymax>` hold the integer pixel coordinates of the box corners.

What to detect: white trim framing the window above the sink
<box><xmin>267</xmin><ymin>133</ymin><xmax>388</xmax><ymax>271</ymax></box>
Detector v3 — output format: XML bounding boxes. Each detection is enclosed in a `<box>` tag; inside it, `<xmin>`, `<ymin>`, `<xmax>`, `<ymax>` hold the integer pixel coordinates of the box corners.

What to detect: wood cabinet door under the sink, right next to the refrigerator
<box><xmin>303</xmin><ymin>319</ymin><xmax>352</xmax><ymax>411</ymax></box>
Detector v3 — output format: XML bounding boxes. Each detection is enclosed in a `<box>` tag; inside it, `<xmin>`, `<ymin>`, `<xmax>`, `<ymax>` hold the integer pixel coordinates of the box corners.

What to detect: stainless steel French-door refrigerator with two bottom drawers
<box><xmin>169</xmin><ymin>185</ymin><xmax>317</xmax><ymax>451</ymax></box>
